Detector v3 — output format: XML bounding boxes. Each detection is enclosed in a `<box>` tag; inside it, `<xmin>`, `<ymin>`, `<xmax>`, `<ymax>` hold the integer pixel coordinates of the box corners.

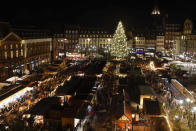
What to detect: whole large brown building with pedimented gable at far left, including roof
<box><xmin>0</xmin><ymin>24</ymin><xmax>52</xmax><ymax>81</ymax></box>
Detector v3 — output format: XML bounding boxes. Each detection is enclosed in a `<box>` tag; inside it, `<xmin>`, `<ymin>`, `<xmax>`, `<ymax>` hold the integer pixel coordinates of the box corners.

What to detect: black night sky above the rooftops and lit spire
<box><xmin>0</xmin><ymin>0</ymin><xmax>196</xmax><ymax>27</ymax></box>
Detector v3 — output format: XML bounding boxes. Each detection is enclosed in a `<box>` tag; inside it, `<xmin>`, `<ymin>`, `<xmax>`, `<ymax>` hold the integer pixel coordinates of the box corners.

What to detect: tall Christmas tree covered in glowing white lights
<box><xmin>110</xmin><ymin>21</ymin><xmax>128</xmax><ymax>59</ymax></box>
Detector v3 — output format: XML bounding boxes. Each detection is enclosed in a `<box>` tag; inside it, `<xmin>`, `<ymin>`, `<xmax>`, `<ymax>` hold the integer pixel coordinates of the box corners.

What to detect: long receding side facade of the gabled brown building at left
<box><xmin>22</xmin><ymin>38</ymin><xmax>52</xmax><ymax>71</ymax></box>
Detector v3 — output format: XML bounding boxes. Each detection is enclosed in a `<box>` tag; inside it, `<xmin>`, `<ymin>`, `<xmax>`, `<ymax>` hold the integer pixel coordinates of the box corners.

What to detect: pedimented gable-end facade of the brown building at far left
<box><xmin>0</xmin><ymin>32</ymin><xmax>24</xmax><ymax>81</ymax></box>
